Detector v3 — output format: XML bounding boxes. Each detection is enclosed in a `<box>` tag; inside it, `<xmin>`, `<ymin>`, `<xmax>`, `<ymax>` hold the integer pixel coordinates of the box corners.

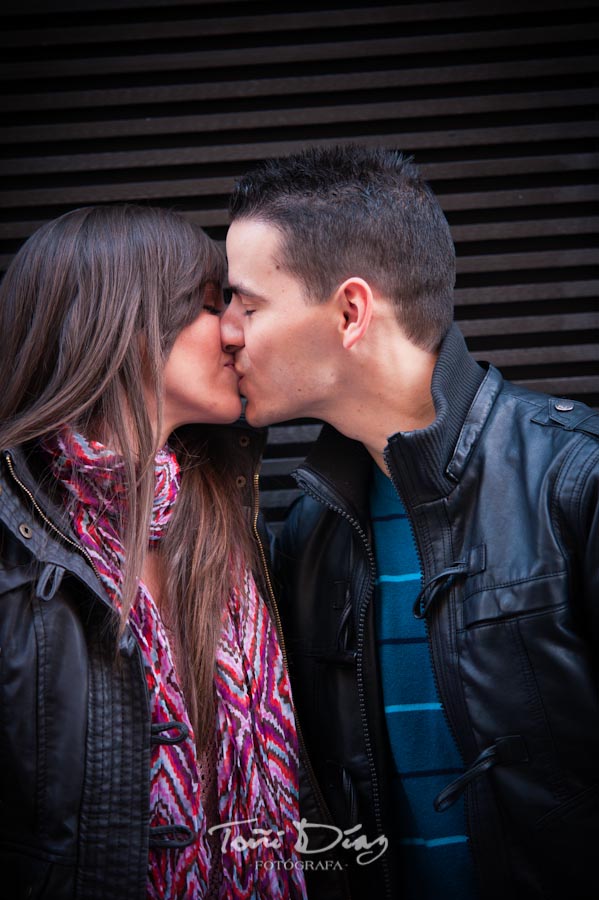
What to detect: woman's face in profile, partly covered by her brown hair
<box><xmin>163</xmin><ymin>285</ymin><xmax>241</xmax><ymax>440</ymax></box>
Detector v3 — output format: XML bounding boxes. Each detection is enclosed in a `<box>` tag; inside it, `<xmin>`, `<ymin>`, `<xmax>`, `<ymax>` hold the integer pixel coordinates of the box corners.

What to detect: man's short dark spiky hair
<box><xmin>229</xmin><ymin>144</ymin><xmax>455</xmax><ymax>350</ymax></box>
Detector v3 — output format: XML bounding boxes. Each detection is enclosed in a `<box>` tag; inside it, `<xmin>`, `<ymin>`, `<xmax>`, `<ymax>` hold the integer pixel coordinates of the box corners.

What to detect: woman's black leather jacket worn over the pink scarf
<box><xmin>0</xmin><ymin>428</ymin><xmax>263</xmax><ymax>900</ymax></box>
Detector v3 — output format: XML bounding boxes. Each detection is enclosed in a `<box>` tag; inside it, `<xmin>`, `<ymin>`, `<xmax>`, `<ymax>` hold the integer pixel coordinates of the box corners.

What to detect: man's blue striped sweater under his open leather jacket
<box><xmin>370</xmin><ymin>466</ymin><xmax>476</xmax><ymax>900</ymax></box>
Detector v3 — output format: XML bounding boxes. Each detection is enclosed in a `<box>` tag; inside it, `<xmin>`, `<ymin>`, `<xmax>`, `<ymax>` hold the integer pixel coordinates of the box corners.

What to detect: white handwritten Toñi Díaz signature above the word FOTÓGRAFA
<box><xmin>208</xmin><ymin>818</ymin><xmax>389</xmax><ymax>866</ymax></box>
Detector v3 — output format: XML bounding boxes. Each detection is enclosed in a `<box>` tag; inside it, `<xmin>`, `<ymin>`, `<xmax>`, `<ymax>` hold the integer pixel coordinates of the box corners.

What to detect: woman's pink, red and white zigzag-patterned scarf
<box><xmin>45</xmin><ymin>429</ymin><xmax>305</xmax><ymax>900</ymax></box>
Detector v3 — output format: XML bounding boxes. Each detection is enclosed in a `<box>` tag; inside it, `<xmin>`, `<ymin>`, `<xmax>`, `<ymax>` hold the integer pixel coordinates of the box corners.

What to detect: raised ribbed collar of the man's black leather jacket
<box><xmin>293</xmin><ymin>324</ymin><xmax>492</xmax><ymax>521</ymax></box>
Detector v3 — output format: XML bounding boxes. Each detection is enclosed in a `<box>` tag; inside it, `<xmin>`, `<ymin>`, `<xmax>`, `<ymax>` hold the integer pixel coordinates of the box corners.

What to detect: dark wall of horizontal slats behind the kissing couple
<box><xmin>0</xmin><ymin>0</ymin><xmax>599</xmax><ymax>521</ymax></box>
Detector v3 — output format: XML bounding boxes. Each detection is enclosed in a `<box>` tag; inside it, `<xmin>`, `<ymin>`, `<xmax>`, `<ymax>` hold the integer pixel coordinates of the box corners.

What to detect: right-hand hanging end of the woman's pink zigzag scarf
<box><xmin>216</xmin><ymin>572</ymin><xmax>304</xmax><ymax>900</ymax></box>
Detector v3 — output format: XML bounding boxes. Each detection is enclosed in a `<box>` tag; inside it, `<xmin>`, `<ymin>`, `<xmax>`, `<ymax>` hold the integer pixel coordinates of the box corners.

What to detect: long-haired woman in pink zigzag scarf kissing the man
<box><xmin>0</xmin><ymin>206</ymin><xmax>304</xmax><ymax>900</ymax></box>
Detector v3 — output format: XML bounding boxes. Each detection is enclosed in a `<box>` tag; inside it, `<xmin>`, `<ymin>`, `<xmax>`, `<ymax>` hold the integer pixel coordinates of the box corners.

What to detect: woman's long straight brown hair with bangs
<box><xmin>0</xmin><ymin>205</ymin><xmax>250</xmax><ymax>747</ymax></box>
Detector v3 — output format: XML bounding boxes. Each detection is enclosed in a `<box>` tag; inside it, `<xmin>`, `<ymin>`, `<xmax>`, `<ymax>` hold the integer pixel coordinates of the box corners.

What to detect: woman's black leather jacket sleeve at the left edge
<box><xmin>0</xmin><ymin>527</ymin><xmax>87</xmax><ymax>900</ymax></box>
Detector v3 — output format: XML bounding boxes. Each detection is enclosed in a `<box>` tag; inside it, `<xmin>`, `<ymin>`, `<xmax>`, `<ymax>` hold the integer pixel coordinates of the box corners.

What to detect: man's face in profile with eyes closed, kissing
<box><xmin>221</xmin><ymin>219</ymin><xmax>338</xmax><ymax>425</ymax></box>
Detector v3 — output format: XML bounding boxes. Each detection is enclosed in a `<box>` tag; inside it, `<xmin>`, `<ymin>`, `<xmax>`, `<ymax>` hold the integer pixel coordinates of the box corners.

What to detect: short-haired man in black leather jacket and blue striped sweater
<box><xmin>222</xmin><ymin>146</ymin><xmax>599</xmax><ymax>900</ymax></box>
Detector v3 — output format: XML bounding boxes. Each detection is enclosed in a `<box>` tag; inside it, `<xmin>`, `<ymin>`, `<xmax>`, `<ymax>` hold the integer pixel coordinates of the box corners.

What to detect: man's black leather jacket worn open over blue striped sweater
<box><xmin>276</xmin><ymin>326</ymin><xmax>599</xmax><ymax>900</ymax></box>
